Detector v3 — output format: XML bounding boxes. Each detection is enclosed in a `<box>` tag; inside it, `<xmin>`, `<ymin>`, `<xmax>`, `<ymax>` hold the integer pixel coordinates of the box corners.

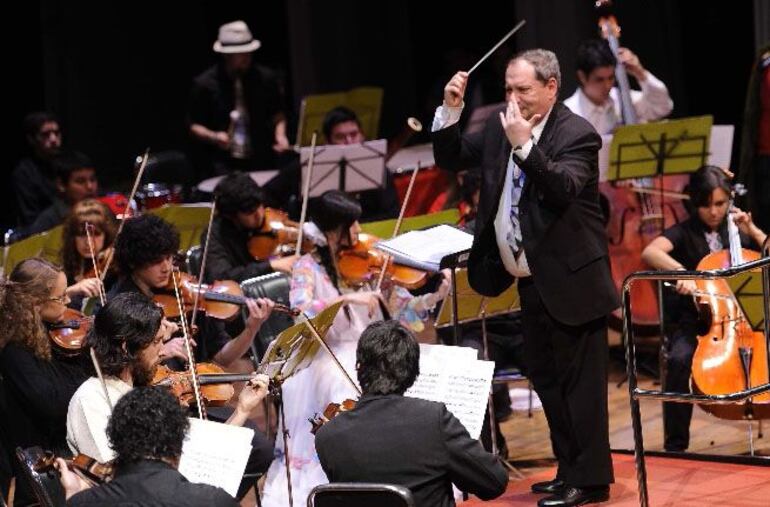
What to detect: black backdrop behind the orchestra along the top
<box><xmin>0</xmin><ymin>0</ymin><xmax>768</xmax><ymax>230</ymax></box>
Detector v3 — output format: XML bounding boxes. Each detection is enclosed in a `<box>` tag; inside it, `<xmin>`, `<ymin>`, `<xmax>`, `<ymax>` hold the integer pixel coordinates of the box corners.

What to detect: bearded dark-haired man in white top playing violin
<box><xmin>66</xmin><ymin>294</ymin><xmax>273</xmax><ymax>497</ymax></box>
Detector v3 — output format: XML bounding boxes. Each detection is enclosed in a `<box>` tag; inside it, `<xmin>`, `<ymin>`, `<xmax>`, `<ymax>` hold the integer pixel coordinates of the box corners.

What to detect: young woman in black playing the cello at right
<box><xmin>642</xmin><ymin>165</ymin><xmax>767</xmax><ymax>451</ymax></box>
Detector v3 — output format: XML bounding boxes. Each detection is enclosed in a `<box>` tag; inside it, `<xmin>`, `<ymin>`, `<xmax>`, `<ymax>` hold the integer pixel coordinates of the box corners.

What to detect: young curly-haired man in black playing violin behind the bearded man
<box><xmin>108</xmin><ymin>215</ymin><xmax>273</xmax><ymax>367</ymax></box>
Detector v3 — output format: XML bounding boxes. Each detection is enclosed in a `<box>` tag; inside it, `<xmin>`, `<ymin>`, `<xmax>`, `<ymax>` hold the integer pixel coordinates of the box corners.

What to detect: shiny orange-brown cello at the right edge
<box><xmin>692</xmin><ymin>194</ymin><xmax>770</xmax><ymax>420</ymax></box>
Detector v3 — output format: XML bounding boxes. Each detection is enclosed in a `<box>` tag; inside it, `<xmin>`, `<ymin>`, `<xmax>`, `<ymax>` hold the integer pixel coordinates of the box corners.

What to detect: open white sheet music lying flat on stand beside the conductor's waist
<box><xmin>375</xmin><ymin>225</ymin><xmax>473</xmax><ymax>271</ymax></box>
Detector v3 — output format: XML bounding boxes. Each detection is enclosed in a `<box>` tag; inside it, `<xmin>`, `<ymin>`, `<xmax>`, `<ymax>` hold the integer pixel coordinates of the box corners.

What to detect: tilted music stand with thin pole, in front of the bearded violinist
<box><xmin>260</xmin><ymin>302</ymin><xmax>347</xmax><ymax>507</ymax></box>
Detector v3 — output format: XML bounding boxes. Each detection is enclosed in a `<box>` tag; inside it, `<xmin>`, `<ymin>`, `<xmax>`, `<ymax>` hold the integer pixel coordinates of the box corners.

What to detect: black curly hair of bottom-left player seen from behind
<box><xmin>107</xmin><ymin>387</ymin><xmax>190</xmax><ymax>467</ymax></box>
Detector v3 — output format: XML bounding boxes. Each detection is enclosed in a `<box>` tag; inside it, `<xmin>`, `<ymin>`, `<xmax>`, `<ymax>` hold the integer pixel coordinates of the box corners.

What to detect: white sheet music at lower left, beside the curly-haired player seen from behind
<box><xmin>179</xmin><ymin>418</ymin><xmax>254</xmax><ymax>498</ymax></box>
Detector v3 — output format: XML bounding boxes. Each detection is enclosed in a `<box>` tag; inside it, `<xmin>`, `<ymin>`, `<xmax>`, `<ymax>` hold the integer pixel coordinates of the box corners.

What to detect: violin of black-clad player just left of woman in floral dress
<box><xmin>247</xmin><ymin>208</ymin><xmax>314</xmax><ymax>260</ymax></box>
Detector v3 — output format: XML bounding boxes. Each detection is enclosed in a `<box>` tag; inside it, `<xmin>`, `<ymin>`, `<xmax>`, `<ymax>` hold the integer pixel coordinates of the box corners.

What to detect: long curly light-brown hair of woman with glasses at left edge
<box><xmin>0</xmin><ymin>257</ymin><xmax>62</xmax><ymax>361</ymax></box>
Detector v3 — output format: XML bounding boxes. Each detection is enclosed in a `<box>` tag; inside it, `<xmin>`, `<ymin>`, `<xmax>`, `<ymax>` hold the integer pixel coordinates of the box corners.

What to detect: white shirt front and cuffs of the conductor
<box><xmin>432</xmin><ymin>103</ymin><xmax>552</xmax><ymax>278</ymax></box>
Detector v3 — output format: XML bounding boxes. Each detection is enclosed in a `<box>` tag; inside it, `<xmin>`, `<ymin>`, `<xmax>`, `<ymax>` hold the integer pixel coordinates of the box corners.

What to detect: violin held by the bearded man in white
<box><xmin>152</xmin><ymin>363</ymin><xmax>264</xmax><ymax>408</ymax></box>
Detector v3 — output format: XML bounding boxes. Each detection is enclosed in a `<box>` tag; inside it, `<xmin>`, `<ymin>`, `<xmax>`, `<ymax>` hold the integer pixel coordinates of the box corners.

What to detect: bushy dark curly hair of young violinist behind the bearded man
<box><xmin>115</xmin><ymin>214</ymin><xmax>179</xmax><ymax>276</ymax></box>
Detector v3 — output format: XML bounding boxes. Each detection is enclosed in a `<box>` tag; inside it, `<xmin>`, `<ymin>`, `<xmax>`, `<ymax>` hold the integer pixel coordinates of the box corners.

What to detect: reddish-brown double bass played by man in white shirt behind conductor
<box><xmin>596</xmin><ymin>0</ymin><xmax>689</xmax><ymax>328</ymax></box>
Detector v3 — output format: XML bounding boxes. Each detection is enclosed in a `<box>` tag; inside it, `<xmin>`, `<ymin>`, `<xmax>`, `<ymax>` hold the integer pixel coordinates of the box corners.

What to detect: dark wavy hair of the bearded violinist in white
<box><xmin>86</xmin><ymin>292</ymin><xmax>163</xmax><ymax>376</ymax></box>
